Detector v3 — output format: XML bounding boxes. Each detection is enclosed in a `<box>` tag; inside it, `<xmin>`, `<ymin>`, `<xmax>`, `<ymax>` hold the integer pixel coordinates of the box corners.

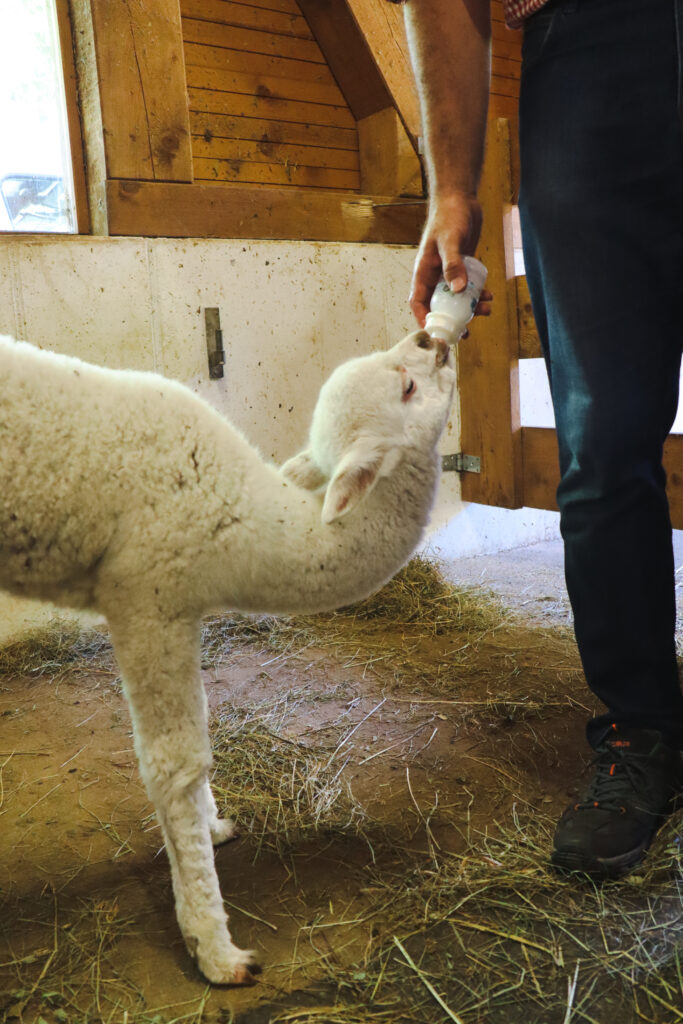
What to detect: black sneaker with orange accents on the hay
<box><xmin>551</xmin><ymin>725</ymin><xmax>683</xmax><ymax>878</ymax></box>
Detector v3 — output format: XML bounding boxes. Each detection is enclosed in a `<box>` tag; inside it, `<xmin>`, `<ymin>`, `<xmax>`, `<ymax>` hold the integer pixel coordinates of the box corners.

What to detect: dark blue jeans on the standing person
<box><xmin>519</xmin><ymin>0</ymin><xmax>683</xmax><ymax>748</ymax></box>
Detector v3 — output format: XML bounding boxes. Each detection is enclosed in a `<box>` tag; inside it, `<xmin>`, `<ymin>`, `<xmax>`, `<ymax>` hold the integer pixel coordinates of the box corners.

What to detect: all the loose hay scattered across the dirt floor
<box><xmin>0</xmin><ymin>559</ymin><xmax>683</xmax><ymax>1024</ymax></box>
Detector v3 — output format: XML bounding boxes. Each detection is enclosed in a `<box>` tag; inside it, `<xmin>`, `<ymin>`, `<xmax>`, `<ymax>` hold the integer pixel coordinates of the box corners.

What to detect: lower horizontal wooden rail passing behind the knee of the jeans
<box><xmin>521</xmin><ymin>427</ymin><xmax>683</xmax><ymax>529</ymax></box>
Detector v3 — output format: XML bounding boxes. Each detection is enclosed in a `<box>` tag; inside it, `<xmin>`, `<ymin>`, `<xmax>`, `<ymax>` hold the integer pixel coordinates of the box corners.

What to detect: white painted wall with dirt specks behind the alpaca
<box><xmin>0</xmin><ymin>237</ymin><xmax>557</xmax><ymax>639</ymax></box>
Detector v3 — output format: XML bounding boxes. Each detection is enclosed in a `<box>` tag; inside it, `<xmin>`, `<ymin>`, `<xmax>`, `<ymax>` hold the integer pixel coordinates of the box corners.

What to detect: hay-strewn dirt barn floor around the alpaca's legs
<box><xmin>0</xmin><ymin>543</ymin><xmax>683</xmax><ymax>1024</ymax></box>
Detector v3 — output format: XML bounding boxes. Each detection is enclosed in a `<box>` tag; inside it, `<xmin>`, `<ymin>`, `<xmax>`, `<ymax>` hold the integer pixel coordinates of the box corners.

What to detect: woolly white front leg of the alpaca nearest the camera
<box><xmin>109</xmin><ymin>613</ymin><xmax>254</xmax><ymax>984</ymax></box>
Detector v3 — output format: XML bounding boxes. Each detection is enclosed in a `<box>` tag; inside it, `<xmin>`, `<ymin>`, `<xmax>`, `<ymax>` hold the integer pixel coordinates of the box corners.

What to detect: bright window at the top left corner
<box><xmin>0</xmin><ymin>0</ymin><xmax>78</xmax><ymax>232</ymax></box>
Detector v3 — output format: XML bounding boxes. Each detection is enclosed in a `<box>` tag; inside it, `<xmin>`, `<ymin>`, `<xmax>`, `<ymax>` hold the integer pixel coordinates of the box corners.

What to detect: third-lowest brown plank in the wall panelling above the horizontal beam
<box><xmin>189</xmin><ymin>111</ymin><xmax>358</xmax><ymax>152</ymax></box>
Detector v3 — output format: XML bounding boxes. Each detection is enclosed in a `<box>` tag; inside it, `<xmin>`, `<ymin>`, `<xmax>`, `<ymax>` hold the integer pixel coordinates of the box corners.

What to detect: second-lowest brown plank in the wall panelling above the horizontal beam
<box><xmin>193</xmin><ymin>136</ymin><xmax>356</xmax><ymax>166</ymax></box>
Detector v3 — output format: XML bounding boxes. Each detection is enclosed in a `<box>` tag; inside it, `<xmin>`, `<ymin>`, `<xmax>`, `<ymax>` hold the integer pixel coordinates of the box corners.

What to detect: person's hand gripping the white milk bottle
<box><xmin>410</xmin><ymin>193</ymin><xmax>493</xmax><ymax>327</ymax></box>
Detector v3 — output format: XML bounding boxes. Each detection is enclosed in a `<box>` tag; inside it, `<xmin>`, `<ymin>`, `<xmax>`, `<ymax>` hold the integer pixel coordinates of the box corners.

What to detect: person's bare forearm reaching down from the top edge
<box><xmin>404</xmin><ymin>0</ymin><xmax>490</xmax><ymax>197</ymax></box>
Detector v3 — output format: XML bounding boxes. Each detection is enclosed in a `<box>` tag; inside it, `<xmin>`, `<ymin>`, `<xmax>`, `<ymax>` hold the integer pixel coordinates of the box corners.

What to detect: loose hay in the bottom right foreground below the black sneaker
<box><xmin>262</xmin><ymin>813</ymin><xmax>683</xmax><ymax>1024</ymax></box>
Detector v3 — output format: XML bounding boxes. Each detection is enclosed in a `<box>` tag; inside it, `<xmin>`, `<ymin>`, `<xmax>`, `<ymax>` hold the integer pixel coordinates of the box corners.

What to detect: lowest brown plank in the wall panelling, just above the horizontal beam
<box><xmin>195</xmin><ymin>151</ymin><xmax>360</xmax><ymax>191</ymax></box>
